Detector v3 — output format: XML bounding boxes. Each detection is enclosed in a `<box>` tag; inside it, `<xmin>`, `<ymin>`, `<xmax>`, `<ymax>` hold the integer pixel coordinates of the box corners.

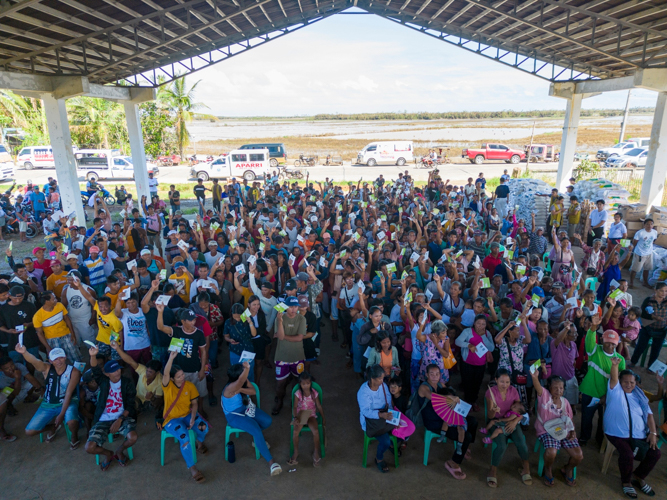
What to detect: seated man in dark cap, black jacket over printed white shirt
<box><xmin>86</xmin><ymin>347</ymin><xmax>137</xmax><ymax>471</ymax></box>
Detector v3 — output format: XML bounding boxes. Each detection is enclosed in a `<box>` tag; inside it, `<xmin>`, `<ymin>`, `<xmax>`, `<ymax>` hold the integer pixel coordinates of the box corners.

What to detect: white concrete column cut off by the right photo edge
<box><xmin>640</xmin><ymin>92</ymin><xmax>667</xmax><ymax>209</ymax></box>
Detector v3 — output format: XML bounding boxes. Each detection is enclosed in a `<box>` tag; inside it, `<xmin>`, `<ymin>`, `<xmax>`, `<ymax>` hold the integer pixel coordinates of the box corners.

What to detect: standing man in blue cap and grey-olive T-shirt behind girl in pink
<box><xmin>271</xmin><ymin>297</ymin><xmax>306</xmax><ymax>415</ymax></box>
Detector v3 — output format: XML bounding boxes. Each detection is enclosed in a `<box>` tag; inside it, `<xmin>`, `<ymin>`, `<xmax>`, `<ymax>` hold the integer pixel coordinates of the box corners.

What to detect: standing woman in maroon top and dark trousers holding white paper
<box><xmin>456</xmin><ymin>314</ymin><xmax>495</xmax><ymax>411</ymax></box>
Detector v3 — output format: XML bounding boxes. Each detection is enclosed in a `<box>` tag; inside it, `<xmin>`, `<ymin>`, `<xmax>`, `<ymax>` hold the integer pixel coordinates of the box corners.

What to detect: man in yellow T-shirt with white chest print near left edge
<box><xmin>32</xmin><ymin>292</ymin><xmax>81</xmax><ymax>363</ymax></box>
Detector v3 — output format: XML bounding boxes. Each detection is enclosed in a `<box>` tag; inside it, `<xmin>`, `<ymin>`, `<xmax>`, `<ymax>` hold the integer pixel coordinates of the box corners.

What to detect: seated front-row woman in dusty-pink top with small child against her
<box><xmin>486</xmin><ymin>368</ymin><xmax>533</xmax><ymax>488</ymax></box>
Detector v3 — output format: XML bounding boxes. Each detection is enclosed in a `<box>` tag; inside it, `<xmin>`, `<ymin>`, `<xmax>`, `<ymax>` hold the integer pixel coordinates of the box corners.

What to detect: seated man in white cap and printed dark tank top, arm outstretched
<box><xmin>16</xmin><ymin>344</ymin><xmax>81</xmax><ymax>450</ymax></box>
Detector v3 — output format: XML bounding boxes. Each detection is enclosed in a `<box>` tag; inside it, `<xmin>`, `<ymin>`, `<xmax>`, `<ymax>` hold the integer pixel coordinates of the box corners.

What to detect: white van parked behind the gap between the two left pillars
<box><xmin>74</xmin><ymin>149</ymin><xmax>160</xmax><ymax>181</ymax></box>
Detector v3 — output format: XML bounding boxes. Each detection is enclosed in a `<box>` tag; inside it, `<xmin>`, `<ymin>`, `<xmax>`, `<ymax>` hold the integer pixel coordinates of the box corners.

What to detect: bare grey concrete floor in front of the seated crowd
<box><xmin>0</xmin><ymin>249</ymin><xmax>667</xmax><ymax>500</ymax></box>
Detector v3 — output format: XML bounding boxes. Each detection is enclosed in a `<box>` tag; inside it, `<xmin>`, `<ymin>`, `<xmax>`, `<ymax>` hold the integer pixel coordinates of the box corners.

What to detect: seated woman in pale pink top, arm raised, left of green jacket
<box><xmin>531</xmin><ymin>365</ymin><xmax>584</xmax><ymax>486</ymax></box>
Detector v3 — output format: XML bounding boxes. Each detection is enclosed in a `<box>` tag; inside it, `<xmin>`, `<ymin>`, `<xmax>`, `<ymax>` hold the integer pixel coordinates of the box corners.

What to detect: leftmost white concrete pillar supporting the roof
<box><xmin>41</xmin><ymin>94</ymin><xmax>86</xmax><ymax>226</ymax></box>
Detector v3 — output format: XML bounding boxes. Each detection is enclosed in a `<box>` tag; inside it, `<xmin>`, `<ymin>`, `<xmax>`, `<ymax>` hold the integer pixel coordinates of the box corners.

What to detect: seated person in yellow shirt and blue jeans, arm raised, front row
<box><xmin>160</xmin><ymin>348</ymin><xmax>208</xmax><ymax>483</ymax></box>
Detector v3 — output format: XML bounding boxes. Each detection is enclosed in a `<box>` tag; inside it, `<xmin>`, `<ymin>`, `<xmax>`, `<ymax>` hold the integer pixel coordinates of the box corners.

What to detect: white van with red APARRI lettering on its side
<box><xmin>190</xmin><ymin>148</ymin><xmax>271</xmax><ymax>181</ymax></box>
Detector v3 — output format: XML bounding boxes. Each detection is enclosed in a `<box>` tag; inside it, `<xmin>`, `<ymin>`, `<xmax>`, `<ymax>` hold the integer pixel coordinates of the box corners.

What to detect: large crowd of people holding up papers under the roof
<box><xmin>0</xmin><ymin>170</ymin><xmax>667</xmax><ymax>498</ymax></box>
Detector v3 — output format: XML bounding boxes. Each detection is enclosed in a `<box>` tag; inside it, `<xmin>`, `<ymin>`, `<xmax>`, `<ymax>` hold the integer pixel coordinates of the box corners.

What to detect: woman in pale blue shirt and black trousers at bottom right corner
<box><xmin>604</xmin><ymin>357</ymin><xmax>660</xmax><ymax>498</ymax></box>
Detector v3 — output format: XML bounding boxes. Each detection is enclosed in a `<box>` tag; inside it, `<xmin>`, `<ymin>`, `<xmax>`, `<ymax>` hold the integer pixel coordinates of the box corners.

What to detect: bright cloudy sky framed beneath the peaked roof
<box><xmin>188</xmin><ymin>7</ymin><xmax>657</xmax><ymax>117</ymax></box>
